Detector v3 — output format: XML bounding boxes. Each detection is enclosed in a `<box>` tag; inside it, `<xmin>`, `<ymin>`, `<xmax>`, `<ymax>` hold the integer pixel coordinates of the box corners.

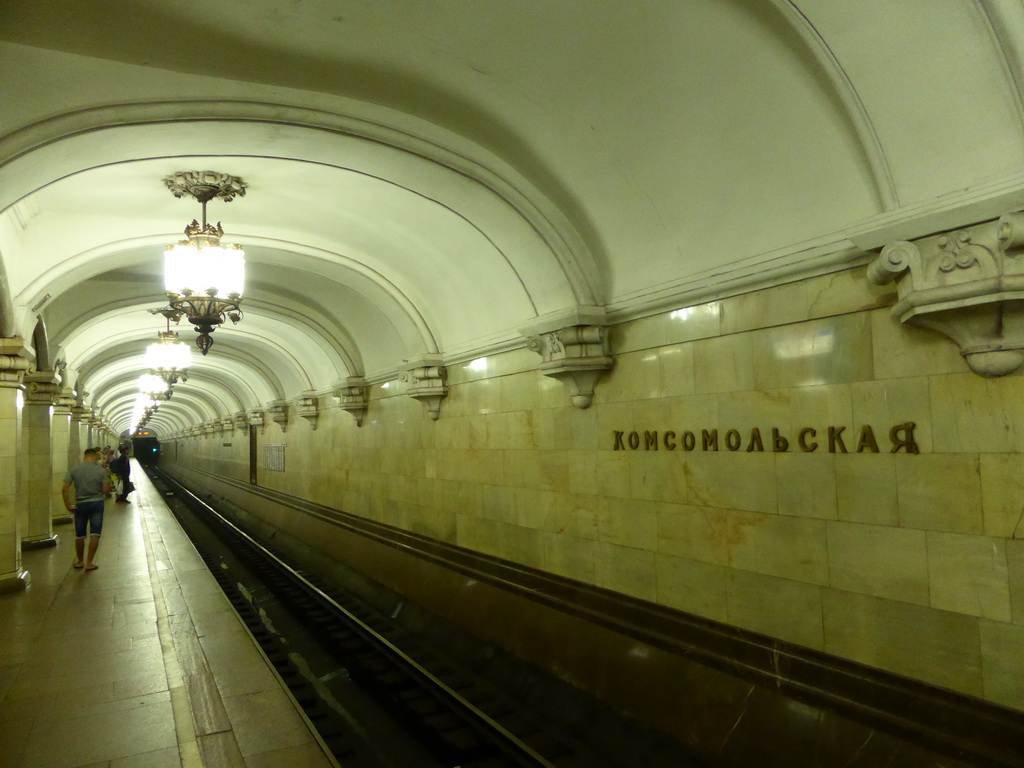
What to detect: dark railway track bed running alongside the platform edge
<box><xmin>146</xmin><ymin>467</ymin><xmax>598</xmax><ymax>768</ymax></box>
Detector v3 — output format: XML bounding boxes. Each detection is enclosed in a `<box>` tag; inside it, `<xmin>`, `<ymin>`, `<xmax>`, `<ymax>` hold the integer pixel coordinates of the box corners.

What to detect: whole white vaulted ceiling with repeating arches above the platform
<box><xmin>0</xmin><ymin>0</ymin><xmax>1024</xmax><ymax>436</ymax></box>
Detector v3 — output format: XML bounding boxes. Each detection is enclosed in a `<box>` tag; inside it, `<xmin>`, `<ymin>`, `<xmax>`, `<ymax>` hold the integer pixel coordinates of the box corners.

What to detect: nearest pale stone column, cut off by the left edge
<box><xmin>0</xmin><ymin>338</ymin><xmax>29</xmax><ymax>592</ymax></box>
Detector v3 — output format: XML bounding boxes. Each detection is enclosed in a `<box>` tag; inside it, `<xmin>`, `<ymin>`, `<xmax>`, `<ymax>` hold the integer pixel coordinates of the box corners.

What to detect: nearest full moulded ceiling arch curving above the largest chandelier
<box><xmin>0</xmin><ymin>101</ymin><xmax>605</xmax><ymax>304</ymax></box>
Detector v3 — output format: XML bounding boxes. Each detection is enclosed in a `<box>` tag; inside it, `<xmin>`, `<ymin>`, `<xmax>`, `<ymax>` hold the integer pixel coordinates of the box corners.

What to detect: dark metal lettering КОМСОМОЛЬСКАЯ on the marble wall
<box><xmin>611</xmin><ymin>421</ymin><xmax>921</xmax><ymax>454</ymax></box>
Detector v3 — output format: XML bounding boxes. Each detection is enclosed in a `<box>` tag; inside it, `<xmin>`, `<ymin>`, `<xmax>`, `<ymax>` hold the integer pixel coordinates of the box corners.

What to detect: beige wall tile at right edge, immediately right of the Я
<box><xmin>931</xmin><ymin>372</ymin><xmax>1024</xmax><ymax>454</ymax></box>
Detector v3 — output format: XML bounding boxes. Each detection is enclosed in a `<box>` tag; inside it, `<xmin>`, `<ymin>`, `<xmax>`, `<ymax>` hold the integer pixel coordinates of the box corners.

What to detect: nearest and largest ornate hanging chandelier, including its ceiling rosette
<box><xmin>164</xmin><ymin>171</ymin><xmax>246</xmax><ymax>354</ymax></box>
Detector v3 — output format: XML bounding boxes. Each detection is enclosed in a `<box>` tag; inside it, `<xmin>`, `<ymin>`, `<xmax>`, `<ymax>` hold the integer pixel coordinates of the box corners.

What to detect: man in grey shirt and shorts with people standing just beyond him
<box><xmin>61</xmin><ymin>442</ymin><xmax>134</xmax><ymax>570</ymax></box>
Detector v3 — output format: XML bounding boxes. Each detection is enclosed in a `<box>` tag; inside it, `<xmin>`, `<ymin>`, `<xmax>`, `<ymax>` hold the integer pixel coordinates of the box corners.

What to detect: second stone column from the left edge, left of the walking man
<box><xmin>22</xmin><ymin>371</ymin><xmax>60</xmax><ymax>550</ymax></box>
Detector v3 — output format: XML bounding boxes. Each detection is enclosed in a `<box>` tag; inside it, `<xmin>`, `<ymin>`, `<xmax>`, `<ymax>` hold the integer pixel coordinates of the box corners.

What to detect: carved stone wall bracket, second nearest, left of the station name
<box><xmin>526</xmin><ymin>326</ymin><xmax>614</xmax><ymax>408</ymax></box>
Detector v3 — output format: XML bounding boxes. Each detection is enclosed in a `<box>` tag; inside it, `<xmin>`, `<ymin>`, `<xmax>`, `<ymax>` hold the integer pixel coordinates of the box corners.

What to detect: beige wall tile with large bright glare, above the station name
<box><xmin>751</xmin><ymin>312</ymin><xmax>872</xmax><ymax>389</ymax></box>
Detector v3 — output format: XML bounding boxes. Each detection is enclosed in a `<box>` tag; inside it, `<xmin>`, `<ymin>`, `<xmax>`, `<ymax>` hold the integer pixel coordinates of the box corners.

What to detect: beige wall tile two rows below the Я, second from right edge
<box><xmin>928</xmin><ymin>530</ymin><xmax>1010</xmax><ymax>622</ymax></box>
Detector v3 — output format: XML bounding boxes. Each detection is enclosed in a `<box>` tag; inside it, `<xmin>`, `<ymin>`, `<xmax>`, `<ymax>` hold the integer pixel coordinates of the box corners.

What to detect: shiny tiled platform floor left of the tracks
<box><xmin>0</xmin><ymin>464</ymin><xmax>337</xmax><ymax>768</ymax></box>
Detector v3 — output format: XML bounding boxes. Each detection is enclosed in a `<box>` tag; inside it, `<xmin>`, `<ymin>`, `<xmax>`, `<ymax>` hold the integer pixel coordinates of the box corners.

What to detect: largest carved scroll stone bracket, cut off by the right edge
<box><xmin>867</xmin><ymin>212</ymin><xmax>1024</xmax><ymax>377</ymax></box>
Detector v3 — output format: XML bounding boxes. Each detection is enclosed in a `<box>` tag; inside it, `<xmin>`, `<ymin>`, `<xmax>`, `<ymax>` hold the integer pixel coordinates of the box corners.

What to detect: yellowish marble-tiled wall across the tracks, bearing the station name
<box><xmin>165</xmin><ymin>268</ymin><xmax>1024</xmax><ymax>709</ymax></box>
